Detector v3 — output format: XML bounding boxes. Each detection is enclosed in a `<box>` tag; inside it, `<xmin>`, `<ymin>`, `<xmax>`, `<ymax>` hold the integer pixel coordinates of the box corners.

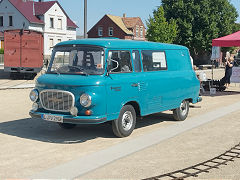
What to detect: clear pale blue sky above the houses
<box><xmin>58</xmin><ymin>0</ymin><xmax>240</xmax><ymax>35</ymax></box>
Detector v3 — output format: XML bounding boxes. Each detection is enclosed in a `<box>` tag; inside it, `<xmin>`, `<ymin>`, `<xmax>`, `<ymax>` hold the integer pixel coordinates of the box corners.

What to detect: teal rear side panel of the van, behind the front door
<box><xmin>141</xmin><ymin>49</ymin><xmax>199</xmax><ymax>115</ymax></box>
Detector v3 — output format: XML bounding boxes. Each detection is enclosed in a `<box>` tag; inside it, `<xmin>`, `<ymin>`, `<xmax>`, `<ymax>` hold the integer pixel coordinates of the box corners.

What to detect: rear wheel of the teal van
<box><xmin>173</xmin><ymin>100</ymin><xmax>189</xmax><ymax>121</ymax></box>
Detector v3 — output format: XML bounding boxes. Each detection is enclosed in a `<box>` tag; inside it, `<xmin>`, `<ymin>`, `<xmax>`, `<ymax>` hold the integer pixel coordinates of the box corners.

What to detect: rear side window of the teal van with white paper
<box><xmin>142</xmin><ymin>50</ymin><xmax>167</xmax><ymax>71</ymax></box>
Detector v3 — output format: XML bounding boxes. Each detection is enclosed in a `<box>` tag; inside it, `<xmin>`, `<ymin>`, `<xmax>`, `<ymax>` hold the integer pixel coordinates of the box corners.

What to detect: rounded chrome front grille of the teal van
<box><xmin>40</xmin><ymin>90</ymin><xmax>74</xmax><ymax>112</ymax></box>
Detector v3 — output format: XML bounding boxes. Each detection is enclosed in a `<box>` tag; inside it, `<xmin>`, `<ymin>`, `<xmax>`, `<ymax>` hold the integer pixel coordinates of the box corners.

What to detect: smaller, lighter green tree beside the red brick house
<box><xmin>146</xmin><ymin>6</ymin><xmax>177</xmax><ymax>43</ymax></box>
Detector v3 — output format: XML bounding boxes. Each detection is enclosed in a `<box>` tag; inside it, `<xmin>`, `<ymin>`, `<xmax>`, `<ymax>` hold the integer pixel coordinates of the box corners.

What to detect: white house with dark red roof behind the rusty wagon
<box><xmin>0</xmin><ymin>0</ymin><xmax>78</xmax><ymax>55</ymax></box>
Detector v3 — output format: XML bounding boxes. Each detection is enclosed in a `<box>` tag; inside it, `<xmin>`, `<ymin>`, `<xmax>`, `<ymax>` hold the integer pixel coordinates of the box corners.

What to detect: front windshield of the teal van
<box><xmin>47</xmin><ymin>45</ymin><xmax>105</xmax><ymax>75</ymax></box>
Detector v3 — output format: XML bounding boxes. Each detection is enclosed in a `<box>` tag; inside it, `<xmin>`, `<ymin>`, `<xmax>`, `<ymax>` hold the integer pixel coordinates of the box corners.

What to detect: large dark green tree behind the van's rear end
<box><xmin>162</xmin><ymin>0</ymin><xmax>238</xmax><ymax>63</ymax></box>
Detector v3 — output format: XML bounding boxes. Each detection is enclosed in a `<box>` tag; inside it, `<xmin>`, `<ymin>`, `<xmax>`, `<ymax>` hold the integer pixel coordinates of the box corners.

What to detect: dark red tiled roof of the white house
<box><xmin>9</xmin><ymin>0</ymin><xmax>78</xmax><ymax>28</ymax></box>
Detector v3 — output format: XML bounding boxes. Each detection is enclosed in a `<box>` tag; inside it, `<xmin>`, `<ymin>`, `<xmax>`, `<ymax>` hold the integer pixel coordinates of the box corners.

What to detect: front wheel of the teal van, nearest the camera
<box><xmin>112</xmin><ymin>105</ymin><xmax>136</xmax><ymax>138</ymax></box>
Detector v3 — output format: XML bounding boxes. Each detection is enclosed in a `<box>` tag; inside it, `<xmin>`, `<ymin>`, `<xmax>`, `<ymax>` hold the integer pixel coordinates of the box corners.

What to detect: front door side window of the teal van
<box><xmin>108</xmin><ymin>51</ymin><xmax>132</xmax><ymax>73</ymax></box>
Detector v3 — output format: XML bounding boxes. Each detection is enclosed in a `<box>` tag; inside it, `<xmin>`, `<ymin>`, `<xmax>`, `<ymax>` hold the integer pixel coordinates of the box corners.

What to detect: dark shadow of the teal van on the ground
<box><xmin>0</xmin><ymin>113</ymin><xmax>174</xmax><ymax>144</ymax></box>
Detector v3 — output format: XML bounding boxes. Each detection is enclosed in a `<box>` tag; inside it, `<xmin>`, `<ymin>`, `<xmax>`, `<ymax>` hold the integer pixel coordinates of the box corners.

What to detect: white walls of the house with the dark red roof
<box><xmin>0</xmin><ymin>0</ymin><xmax>76</xmax><ymax>56</ymax></box>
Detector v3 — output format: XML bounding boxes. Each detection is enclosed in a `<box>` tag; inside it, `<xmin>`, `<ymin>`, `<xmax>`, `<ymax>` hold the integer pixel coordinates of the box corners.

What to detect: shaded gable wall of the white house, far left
<box><xmin>0</xmin><ymin>0</ymin><xmax>29</xmax><ymax>31</ymax></box>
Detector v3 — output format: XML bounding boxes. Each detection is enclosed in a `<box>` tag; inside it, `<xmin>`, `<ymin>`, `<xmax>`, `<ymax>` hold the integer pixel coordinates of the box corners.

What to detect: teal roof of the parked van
<box><xmin>56</xmin><ymin>38</ymin><xmax>187</xmax><ymax>49</ymax></box>
